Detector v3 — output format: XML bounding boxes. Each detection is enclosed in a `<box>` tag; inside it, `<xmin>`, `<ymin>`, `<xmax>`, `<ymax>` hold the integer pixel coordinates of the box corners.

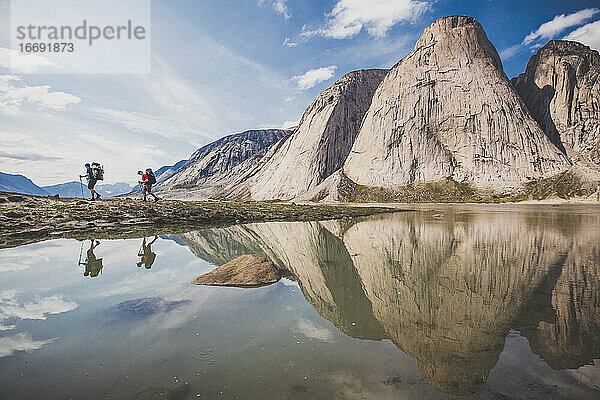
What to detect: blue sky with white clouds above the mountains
<box><xmin>0</xmin><ymin>0</ymin><xmax>600</xmax><ymax>185</ymax></box>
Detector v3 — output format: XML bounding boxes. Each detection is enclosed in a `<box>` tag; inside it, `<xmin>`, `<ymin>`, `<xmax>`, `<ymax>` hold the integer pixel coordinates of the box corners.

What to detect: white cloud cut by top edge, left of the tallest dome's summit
<box><xmin>301</xmin><ymin>0</ymin><xmax>430</xmax><ymax>39</ymax></box>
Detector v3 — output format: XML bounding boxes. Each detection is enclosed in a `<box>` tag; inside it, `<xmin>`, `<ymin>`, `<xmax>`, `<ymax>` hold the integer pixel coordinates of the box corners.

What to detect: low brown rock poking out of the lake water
<box><xmin>190</xmin><ymin>254</ymin><xmax>281</xmax><ymax>287</ymax></box>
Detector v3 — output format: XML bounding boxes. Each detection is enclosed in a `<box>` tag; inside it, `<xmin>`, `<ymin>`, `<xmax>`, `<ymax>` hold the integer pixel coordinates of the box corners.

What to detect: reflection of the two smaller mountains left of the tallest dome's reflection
<box><xmin>181</xmin><ymin>222</ymin><xmax>385</xmax><ymax>340</ymax></box>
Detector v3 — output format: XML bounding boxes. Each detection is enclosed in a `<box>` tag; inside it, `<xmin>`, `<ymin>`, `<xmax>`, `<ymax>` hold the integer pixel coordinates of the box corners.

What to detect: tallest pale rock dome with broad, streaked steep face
<box><xmin>343</xmin><ymin>16</ymin><xmax>569</xmax><ymax>190</ymax></box>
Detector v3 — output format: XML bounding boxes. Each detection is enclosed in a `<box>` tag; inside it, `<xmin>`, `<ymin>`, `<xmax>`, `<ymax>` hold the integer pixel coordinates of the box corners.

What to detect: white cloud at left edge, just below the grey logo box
<box><xmin>0</xmin><ymin>75</ymin><xmax>81</xmax><ymax>115</ymax></box>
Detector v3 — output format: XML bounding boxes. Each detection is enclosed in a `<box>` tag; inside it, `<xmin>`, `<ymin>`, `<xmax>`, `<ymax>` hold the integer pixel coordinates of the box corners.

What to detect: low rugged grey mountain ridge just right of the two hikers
<box><xmin>157</xmin><ymin>129</ymin><xmax>292</xmax><ymax>198</ymax></box>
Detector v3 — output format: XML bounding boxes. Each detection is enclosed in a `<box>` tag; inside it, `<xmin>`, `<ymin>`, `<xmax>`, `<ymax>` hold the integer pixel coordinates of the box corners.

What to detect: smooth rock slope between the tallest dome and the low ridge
<box><xmin>249</xmin><ymin>69</ymin><xmax>387</xmax><ymax>200</ymax></box>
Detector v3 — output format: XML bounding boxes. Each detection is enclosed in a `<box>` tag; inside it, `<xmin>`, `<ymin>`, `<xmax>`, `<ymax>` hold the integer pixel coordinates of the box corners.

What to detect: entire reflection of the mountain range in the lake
<box><xmin>177</xmin><ymin>212</ymin><xmax>600</xmax><ymax>394</ymax></box>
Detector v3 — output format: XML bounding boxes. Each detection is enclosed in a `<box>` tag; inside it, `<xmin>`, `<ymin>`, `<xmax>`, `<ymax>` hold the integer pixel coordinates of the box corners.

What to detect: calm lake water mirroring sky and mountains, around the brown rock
<box><xmin>0</xmin><ymin>207</ymin><xmax>600</xmax><ymax>399</ymax></box>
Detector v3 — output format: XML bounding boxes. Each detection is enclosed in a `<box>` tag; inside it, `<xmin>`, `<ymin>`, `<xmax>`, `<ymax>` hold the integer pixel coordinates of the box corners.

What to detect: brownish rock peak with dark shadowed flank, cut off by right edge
<box><xmin>512</xmin><ymin>40</ymin><xmax>600</xmax><ymax>165</ymax></box>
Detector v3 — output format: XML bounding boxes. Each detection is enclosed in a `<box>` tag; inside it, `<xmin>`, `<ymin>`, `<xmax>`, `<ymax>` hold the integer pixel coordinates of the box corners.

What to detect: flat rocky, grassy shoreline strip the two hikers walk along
<box><xmin>0</xmin><ymin>192</ymin><xmax>399</xmax><ymax>248</ymax></box>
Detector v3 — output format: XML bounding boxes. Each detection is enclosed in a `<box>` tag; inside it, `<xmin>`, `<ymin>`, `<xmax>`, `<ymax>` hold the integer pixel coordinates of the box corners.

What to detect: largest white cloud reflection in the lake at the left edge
<box><xmin>0</xmin><ymin>290</ymin><xmax>78</xmax><ymax>330</ymax></box>
